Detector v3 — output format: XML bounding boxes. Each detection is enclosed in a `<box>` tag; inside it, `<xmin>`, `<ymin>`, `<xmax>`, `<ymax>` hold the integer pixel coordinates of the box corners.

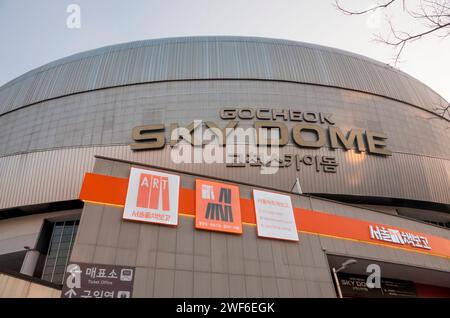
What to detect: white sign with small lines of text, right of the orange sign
<box><xmin>253</xmin><ymin>190</ymin><xmax>298</xmax><ymax>241</ymax></box>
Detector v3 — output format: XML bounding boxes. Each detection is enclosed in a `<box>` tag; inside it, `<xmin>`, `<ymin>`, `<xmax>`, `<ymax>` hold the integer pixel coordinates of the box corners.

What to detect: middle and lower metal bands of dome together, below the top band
<box><xmin>0</xmin><ymin>80</ymin><xmax>450</xmax><ymax>209</ymax></box>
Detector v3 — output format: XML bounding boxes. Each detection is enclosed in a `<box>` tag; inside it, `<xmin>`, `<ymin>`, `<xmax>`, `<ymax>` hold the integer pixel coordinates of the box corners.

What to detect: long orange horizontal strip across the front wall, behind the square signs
<box><xmin>80</xmin><ymin>173</ymin><xmax>450</xmax><ymax>258</ymax></box>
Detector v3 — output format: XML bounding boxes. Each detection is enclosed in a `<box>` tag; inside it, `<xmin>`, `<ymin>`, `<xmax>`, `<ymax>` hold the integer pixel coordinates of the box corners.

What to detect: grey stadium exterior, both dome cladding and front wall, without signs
<box><xmin>0</xmin><ymin>37</ymin><xmax>450</xmax><ymax>297</ymax></box>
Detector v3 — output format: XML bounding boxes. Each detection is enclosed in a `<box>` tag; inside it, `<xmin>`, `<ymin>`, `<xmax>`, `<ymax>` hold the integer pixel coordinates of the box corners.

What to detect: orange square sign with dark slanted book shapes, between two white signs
<box><xmin>195</xmin><ymin>179</ymin><xmax>242</xmax><ymax>233</ymax></box>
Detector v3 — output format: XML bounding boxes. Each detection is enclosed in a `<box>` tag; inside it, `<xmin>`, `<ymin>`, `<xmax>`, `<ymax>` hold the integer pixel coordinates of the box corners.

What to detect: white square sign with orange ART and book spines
<box><xmin>123</xmin><ymin>168</ymin><xmax>180</xmax><ymax>225</ymax></box>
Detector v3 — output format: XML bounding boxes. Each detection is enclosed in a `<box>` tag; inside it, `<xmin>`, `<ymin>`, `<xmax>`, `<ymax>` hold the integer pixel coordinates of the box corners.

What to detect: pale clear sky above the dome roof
<box><xmin>0</xmin><ymin>0</ymin><xmax>450</xmax><ymax>101</ymax></box>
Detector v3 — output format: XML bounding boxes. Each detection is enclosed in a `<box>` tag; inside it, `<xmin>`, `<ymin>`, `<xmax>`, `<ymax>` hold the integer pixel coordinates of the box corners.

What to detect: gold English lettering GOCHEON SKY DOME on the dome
<box><xmin>130</xmin><ymin>108</ymin><xmax>392</xmax><ymax>156</ymax></box>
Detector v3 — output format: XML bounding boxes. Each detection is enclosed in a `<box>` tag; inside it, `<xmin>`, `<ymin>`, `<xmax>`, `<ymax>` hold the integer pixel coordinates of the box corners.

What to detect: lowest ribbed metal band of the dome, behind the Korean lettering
<box><xmin>0</xmin><ymin>146</ymin><xmax>450</xmax><ymax>209</ymax></box>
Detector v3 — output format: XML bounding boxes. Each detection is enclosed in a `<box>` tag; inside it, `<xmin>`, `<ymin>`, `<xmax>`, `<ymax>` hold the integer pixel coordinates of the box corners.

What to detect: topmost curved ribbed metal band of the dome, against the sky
<box><xmin>0</xmin><ymin>36</ymin><xmax>445</xmax><ymax>114</ymax></box>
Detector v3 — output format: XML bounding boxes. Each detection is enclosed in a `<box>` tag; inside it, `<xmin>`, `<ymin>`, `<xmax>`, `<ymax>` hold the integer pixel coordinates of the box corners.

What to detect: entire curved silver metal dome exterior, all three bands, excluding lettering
<box><xmin>0</xmin><ymin>37</ymin><xmax>450</xmax><ymax>210</ymax></box>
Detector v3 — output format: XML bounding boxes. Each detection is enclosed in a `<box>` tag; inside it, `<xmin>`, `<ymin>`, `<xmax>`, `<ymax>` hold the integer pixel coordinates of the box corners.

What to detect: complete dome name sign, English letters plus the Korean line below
<box><xmin>130</xmin><ymin>108</ymin><xmax>392</xmax><ymax>174</ymax></box>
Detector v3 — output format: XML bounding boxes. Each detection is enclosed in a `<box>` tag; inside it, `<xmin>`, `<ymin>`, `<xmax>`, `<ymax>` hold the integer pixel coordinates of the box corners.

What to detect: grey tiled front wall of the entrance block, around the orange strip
<box><xmin>70</xmin><ymin>159</ymin><xmax>450</xmax><ymax>297</ymax></box>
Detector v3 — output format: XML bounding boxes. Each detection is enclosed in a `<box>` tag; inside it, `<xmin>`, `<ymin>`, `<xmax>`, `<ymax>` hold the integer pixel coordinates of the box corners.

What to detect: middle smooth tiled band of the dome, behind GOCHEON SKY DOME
<box><xmin>0</xmin><ymin>80</ymin><xmax>450</xmax><ymax>159</ymax></box>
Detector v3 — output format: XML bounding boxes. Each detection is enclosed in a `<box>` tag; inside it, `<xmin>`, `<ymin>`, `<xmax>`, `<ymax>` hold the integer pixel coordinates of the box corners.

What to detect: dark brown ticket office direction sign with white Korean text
<box><xmin>61</xmin><ymin>263</ymin><xmax>135</xmax><ymax>298</ymax></box>
